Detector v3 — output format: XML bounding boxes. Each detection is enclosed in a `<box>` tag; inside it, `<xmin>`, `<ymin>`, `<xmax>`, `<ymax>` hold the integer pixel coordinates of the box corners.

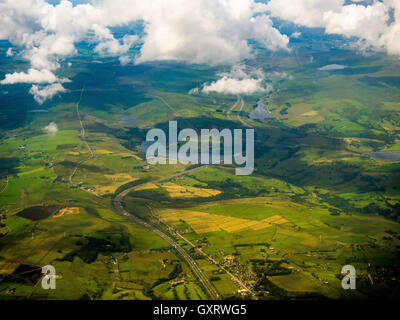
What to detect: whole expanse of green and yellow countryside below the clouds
<box><xmin>0</xmin><ymin>1</ymin><xmax>400</xmax><ymax>300</ymax></box>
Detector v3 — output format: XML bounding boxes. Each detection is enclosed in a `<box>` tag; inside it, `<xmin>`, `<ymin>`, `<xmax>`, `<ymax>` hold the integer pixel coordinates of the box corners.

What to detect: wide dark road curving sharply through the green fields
<box><xmin>114</xmin><ymin>166</ymin><xmax>220</xmax><ymax>300</ymax></box>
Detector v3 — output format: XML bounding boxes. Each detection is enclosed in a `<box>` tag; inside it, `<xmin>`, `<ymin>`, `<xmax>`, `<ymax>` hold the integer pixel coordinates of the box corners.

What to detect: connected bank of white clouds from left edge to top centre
<box><xmin>0</xmin><ymin>0</ymin><xmax>289</xmax><ymax>101</ymax></box>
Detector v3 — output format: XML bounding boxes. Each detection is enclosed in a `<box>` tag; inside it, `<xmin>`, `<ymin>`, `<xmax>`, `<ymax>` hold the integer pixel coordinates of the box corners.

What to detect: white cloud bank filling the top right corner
<box><xmin>267</xmin><ymin>0</ymin><xmax>400</xmax><ymax>55</ymax></box>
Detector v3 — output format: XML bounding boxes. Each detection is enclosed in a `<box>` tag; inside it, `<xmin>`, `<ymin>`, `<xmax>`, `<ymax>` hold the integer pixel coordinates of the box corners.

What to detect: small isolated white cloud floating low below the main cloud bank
<box><xmin>194</xmin><ymin>65</ymin><xmax>272</xmax><ymax>94</ymax></box>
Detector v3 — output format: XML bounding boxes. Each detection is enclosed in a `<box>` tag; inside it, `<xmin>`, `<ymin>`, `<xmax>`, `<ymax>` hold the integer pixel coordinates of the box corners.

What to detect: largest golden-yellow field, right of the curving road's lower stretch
<box><xmin>158</xmin><ymin>209</ymin><xmax>289</xmax><ymax>234</ymax></box>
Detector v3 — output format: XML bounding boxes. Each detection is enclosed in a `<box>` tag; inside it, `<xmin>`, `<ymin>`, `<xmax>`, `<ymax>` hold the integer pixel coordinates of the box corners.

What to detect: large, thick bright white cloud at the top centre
<box><xmin>129</xmin><ymin>0</ymin><xmax>289</xmax><ymax>65</ymax></box>
